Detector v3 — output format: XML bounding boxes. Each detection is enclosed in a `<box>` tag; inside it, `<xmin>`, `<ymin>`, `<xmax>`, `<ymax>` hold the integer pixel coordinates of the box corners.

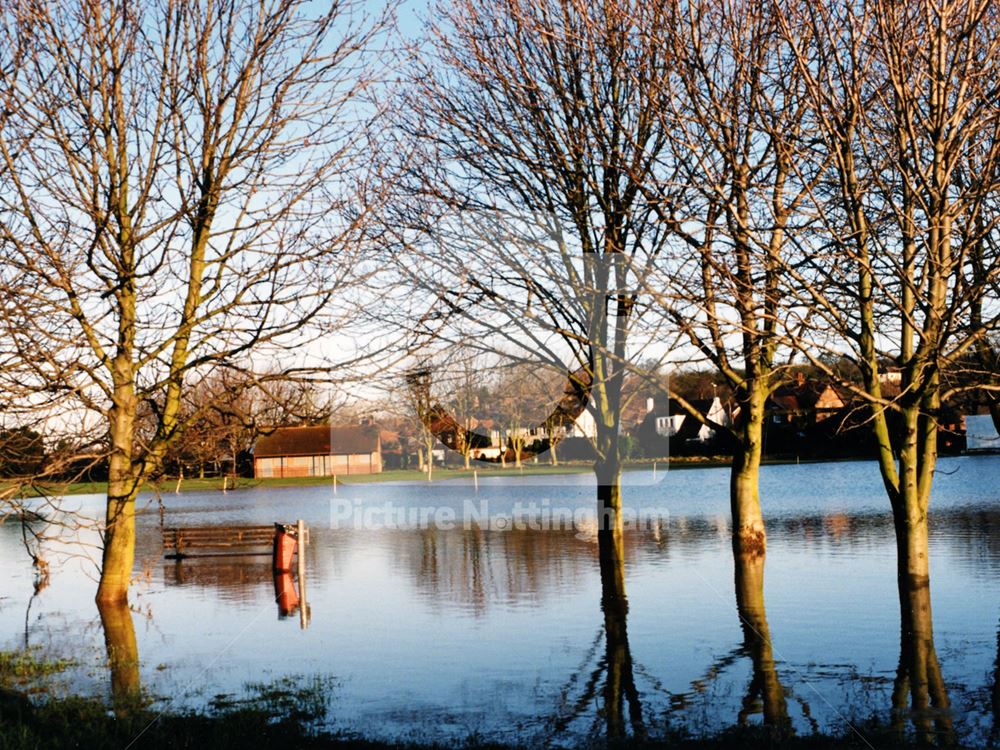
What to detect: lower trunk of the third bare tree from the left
<box><xmin>729</xmin><ymin>388</ymin><xmax>767</xmax><ymax>555</ymax></box>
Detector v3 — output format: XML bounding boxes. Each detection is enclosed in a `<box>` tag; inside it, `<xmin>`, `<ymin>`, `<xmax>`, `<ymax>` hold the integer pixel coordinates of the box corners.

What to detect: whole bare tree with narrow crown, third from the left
<box><xmin>646</xmin><ymin>0</ymin><xmax>821</xmax><ymax>553</ymax></box>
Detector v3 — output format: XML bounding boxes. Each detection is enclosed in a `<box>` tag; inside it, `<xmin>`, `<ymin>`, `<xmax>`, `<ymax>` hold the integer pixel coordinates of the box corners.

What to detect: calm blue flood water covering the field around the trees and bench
<box><xmin>0</xmin><ymin>456</ymin><xmax>1000</xmax><ymax>747</ymax></box>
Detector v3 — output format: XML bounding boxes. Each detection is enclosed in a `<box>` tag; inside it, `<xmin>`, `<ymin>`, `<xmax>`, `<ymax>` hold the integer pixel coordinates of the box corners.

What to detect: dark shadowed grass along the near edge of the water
<box><xmin>0</xmin><ymin>683</ymin><xmax>968</xmax><ymax>750</ymax></box>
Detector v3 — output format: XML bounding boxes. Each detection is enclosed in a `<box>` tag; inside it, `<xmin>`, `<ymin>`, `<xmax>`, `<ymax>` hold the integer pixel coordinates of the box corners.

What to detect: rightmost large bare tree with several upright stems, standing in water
<box><xmin>781</xmin><ymin>0</ymin><xmax>1000</xmax><ymax>588</ymax></box>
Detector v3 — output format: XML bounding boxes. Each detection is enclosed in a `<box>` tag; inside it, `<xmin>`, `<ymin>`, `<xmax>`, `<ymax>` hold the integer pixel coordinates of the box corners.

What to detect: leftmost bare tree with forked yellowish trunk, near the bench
<box><xmin>0</xmin><ymin>0</ymin><xmax>383</xmax><ymax>600</ymax></box>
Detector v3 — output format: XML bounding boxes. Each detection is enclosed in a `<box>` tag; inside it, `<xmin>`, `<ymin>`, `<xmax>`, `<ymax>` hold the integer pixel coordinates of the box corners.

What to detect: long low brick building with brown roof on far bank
<box><xmin>253</xmin><ymin>425</ymin><xmax>382</xmax><ymax>479</ymax></box>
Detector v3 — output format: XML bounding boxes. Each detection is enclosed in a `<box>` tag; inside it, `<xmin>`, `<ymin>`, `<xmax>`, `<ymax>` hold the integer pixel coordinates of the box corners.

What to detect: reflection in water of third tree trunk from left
<box><xmin>733</xmin><ymin>550</ymin><xmax>791</xmax><ymax>734</ymax></box>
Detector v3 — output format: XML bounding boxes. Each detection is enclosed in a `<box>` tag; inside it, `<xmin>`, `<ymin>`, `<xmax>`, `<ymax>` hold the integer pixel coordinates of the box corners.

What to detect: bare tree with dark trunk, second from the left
<box><xmin>393</xmin><ymin>0</ymin><xmax>668</xmax><ymax>564</ymax></box>
